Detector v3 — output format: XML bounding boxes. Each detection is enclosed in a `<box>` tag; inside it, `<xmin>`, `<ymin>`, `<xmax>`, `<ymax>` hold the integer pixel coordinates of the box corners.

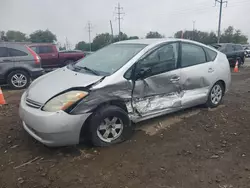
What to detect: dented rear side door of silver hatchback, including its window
<box><xmin>180</xmin><ymin>43</ymin><xmax>216</xmax><ymax>108</ymax></box>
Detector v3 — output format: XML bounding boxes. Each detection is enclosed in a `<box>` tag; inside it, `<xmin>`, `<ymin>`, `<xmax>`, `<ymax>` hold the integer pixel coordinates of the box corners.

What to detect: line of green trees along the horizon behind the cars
<box><xmin>0</xmin><ymin>26</ymin><xmax>248</xmax><ymax>51</ymax></box>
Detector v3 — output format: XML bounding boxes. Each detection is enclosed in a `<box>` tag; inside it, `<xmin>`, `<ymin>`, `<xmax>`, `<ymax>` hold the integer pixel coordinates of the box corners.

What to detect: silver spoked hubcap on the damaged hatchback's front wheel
<box><xmin>97</xmin><ymin>117</ymin><xmax>123</xmax><ymax>142</ymax></box>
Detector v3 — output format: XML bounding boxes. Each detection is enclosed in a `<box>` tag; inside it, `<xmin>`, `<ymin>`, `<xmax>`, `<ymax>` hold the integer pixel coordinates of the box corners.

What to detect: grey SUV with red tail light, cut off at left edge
<box><xmin>0</xmin><ymin>42</ymin><xmax>44</xmax><ymax>89</ymax></box>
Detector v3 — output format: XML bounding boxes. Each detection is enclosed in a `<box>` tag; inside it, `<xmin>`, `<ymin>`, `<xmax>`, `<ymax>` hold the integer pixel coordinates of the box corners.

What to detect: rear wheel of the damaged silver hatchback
<box><xmin>205</xmin><ymin>82</ymin><xmax>225</xmax><ymax>108</ymax></box>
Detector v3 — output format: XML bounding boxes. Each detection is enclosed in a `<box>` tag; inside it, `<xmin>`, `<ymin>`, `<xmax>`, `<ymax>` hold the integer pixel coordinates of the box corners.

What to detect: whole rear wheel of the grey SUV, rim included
<box><xmin>7</xmin><ymin>70</ymin><xmax>30</xmax><ymax>89</ymax></box>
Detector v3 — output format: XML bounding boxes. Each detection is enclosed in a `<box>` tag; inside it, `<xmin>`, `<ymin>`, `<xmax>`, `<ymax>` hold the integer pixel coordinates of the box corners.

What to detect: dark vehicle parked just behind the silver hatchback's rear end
<box><xmin>212</xmin><ymin>43</ymin><xmax>245</xmax><ymax>67</ymax></box>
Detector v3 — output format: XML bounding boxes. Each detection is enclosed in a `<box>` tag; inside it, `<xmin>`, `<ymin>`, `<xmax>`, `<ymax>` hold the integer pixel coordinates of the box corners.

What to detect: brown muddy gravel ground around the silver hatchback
<box><xmin>0</xmin><ymin>63</ymin><xmax>250</xmax><ymax>188</ymax></box>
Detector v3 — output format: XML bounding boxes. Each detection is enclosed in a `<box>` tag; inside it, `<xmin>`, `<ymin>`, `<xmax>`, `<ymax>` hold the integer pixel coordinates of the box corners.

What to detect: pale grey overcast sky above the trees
<box><xmin>0</xmin><ymin>0</ymin><xmax>250</xmax><ymax>46</ymax></box>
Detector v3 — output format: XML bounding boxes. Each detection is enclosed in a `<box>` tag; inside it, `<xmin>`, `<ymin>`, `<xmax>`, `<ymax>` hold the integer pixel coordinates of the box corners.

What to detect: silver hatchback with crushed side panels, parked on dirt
<box><xmin>19</xmin><ymin>39</ymin><xmax>231</xmax><ymax>146</ymax></box>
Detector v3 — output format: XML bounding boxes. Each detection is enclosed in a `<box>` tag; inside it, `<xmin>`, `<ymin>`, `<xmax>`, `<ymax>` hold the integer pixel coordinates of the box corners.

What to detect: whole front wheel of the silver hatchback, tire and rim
<box><xmin>88</xmin><ymin>106</ymin><xmax>134</xmax><ymax>147</ymax></box>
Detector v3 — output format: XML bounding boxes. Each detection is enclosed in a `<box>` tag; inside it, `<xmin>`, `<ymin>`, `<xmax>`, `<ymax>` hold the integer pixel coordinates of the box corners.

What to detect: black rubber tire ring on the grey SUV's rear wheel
<box><xmin>7</xmin><ymin>70</ymin><xmax>30</xmax><ymax>89</ymax></box>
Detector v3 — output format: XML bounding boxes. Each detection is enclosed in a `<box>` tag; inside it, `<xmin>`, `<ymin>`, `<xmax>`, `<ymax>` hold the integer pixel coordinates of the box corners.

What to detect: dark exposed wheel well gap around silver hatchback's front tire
<box><xmin>79</xmin><ymin>100</ymin><xmax>128</xmax><ymax>142</ymax></box>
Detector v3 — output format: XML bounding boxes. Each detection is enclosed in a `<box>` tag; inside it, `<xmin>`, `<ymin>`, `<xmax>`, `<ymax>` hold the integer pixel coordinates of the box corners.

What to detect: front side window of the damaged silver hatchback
<box><xmin>138</xmin><ymin>43</ymin><xmax>179</xmax><ymax>77</ymax></box>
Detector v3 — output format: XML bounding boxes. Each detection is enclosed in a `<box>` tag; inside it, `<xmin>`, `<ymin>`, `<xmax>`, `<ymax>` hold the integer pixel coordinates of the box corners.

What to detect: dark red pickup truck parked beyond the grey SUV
<box><xmin>29</xmin><ymin>43</ymin><xmax>84</xmax><ymax>68</ymax></box>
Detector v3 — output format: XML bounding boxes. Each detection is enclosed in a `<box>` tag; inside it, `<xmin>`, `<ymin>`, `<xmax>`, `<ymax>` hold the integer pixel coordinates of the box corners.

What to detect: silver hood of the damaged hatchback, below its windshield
<box><xmin>27</xmin><ymin>67</ymin><xmax>103</xmax><ymax>104</ymax></box>
